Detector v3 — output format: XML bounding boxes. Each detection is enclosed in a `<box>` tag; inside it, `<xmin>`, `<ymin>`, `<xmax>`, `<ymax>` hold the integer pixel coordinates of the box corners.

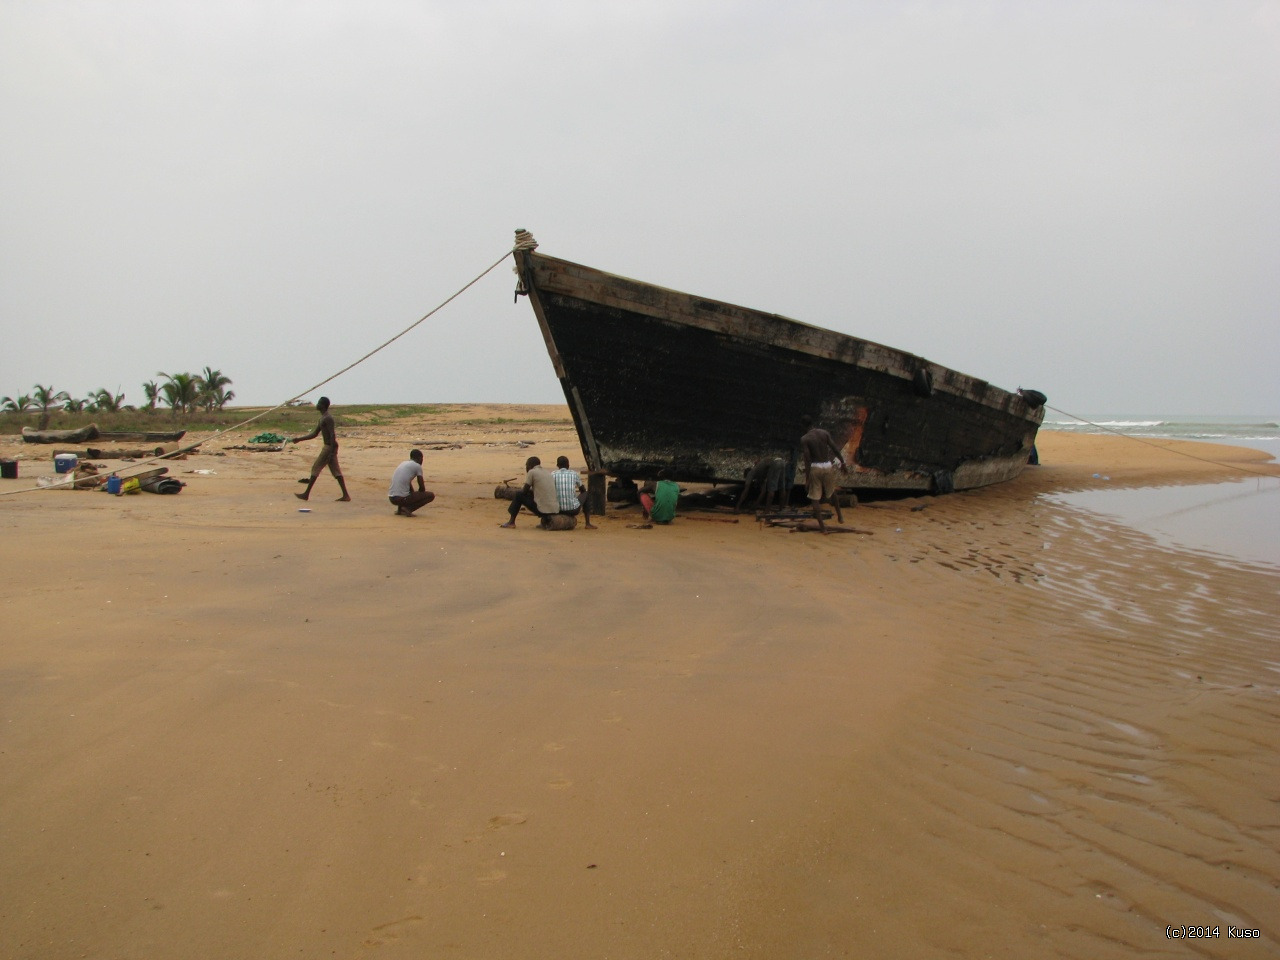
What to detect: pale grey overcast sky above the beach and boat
<box><xmin>0</xmin><ymin>0</ymin><xmax>1280</xmax><ymax>416</ymax></box>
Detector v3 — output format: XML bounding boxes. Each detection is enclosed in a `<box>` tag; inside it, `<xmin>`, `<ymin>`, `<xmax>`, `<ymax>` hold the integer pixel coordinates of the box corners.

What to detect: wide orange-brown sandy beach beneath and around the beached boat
<box><xmin>0</xmin><ymin>404</ymin><xmax>1280</xmax><ymax>960</ymax></box>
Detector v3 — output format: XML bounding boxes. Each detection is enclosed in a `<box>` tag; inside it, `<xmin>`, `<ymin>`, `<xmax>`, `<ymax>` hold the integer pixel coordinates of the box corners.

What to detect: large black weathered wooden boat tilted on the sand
<box><xmin>515</xmin><ymin>230</ymin><xmax>1044</xmax><ymax>493</ymax></box>
